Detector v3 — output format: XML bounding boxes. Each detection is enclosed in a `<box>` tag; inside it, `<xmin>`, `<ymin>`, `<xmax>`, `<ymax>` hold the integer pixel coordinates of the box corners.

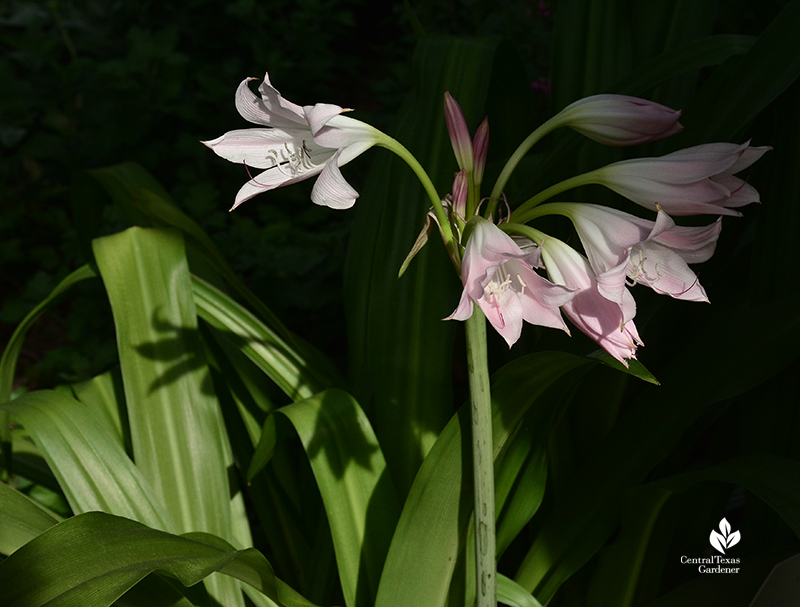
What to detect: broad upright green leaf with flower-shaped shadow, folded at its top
<box><xmin>92</xmin><ymin>228</ymin><xmax>247</xmax><ymax>605</ymax></box>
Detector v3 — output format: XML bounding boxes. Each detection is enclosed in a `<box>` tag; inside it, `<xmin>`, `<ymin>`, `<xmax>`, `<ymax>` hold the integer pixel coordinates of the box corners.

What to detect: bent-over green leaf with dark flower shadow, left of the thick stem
<box><xmin>274</xmin><ymin>390</ymin><xmax>400</xmax><ymax>607</ymax></box>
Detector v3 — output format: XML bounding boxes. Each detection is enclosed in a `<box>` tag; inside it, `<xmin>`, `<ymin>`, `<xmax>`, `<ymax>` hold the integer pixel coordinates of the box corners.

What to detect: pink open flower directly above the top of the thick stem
<box><xmin>448</xmin><ymin>218</ymin><xmax>573</xmax><ymax>347</ymax></box>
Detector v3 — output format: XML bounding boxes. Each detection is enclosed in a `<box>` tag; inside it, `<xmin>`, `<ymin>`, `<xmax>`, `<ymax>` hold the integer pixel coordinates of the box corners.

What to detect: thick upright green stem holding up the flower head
<box><xmin>466</xmin><ymin>306</ymin><xmax>497</xmax><ymax>607</ymax></box>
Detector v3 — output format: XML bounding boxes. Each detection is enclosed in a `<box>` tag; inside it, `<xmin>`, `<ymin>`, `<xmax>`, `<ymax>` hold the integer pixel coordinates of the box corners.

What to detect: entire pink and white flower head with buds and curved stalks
<box><xmin>204</xmin><ymin>76</ymin><xmax>770</xmax><ymax>365</ymax></box>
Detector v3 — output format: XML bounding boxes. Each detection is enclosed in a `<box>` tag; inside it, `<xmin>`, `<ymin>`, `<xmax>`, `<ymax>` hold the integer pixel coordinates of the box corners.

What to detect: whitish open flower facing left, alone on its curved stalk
<box><xmin>203</xmin><ymin>75</ymin><xmax>381</xmax><ymax>210</ymax></box>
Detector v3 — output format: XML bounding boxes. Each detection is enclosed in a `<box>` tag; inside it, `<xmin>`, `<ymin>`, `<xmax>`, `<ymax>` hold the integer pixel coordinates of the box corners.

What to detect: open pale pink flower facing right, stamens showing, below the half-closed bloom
<box><xmin>552</xmin><ymin>203</ymin><xmax>722</xmax><ymax>304</ymax></box>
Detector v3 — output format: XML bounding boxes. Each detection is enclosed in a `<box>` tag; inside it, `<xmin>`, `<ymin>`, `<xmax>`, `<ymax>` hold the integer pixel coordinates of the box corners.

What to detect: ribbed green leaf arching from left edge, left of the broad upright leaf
<box><xmin>3</xmin><ymin>390</ymin><xmax>176</xmax><ymax>531</ymax></box>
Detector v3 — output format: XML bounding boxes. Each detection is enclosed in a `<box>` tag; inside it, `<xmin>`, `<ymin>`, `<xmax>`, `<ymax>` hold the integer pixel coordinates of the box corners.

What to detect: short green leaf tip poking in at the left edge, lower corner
<box><xmin>0</xmin><ymin>483</ymin><xmax>61</xmax><ymax>554</ymax></box>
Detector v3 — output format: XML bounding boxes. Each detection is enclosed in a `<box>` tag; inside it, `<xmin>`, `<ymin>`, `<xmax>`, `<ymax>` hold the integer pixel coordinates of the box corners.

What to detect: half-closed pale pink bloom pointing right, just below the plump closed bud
<box><xmin>590</xmin><ymin>141</ymin><xmax>771</xmax><ymax>216</ymax></box>
